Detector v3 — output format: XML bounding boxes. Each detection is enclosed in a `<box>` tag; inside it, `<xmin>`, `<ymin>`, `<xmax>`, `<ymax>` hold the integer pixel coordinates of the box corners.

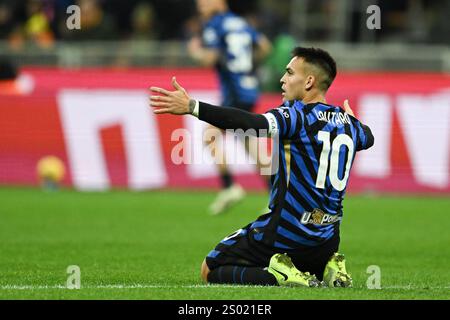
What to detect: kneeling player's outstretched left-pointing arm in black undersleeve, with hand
<box><xmin>150</xmin><ymin>77</ymin><xmax>269</xmax><ymax>135</ymax></box>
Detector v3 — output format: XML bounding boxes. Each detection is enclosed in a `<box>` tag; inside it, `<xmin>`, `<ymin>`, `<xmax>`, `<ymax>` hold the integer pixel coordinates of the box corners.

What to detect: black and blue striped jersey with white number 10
<box><xmin>250</xmin><ymin>100</ymin><xmax>374</xmax><ymax>249</ymax></box>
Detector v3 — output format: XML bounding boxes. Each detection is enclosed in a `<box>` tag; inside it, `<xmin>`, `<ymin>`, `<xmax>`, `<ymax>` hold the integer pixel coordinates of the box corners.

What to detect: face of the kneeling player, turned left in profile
<box><xmin>280</xmin><ymin>57</ymin><xmax>307</xmax><ymax>101</ymax></box>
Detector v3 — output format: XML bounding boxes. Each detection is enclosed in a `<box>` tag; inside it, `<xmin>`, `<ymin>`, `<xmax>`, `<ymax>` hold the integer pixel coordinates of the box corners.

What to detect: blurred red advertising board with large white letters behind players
<box><xmin>0</xmin><ymin>68</ymin><xmax>450</xmax><ymax>194</ymax></box>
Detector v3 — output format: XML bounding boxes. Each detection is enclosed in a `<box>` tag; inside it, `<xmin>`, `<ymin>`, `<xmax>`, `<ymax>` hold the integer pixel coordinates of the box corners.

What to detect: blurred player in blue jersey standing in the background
<box><xmin>188</xmin><ymin>0</ymin><xmax>271</xmax><ymax>214</ymax></box>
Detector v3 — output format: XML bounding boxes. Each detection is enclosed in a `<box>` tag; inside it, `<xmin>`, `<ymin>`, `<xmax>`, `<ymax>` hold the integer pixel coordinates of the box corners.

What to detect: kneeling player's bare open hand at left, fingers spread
<box><xmin>150</xmin><ymin>77</ymin><xmax>190</xmax><ymax>114</ymax></box>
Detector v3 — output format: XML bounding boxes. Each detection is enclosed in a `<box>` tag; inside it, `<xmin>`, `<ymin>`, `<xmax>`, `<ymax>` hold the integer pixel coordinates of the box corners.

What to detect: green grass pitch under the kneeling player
<box><xmin>0</xmin><ymin>187</ymin><xmax>450</xmax><ymax>300</ymax></box>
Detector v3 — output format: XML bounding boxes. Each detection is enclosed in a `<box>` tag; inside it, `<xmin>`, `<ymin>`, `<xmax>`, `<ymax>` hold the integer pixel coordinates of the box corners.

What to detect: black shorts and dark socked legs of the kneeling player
<box><xmin>206</xmin><ymin>224</ymin><xmax>340</xmax><ymax>280</ymax></box>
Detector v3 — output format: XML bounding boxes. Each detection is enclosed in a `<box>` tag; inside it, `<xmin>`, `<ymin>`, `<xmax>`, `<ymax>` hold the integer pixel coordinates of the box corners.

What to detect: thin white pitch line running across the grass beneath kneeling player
<box><xmin>0</xmin><ymin>284</ymin><xmax>450</xmax><ymax>290</ymax></box>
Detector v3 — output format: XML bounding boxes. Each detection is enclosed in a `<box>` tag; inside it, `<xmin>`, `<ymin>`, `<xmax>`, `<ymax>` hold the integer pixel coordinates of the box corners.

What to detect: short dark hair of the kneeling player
<box><xmin>292</xmin><ymin>47</ymin><xmax>336</xmax><ymax>91</ymax></box>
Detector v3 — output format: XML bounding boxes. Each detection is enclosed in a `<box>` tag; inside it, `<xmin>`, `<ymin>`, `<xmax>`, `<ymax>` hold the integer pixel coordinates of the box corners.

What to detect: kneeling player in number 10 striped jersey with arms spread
<box><xmin>151</xmin><ymin>47</ymin><xmax>374</xmax><ymax>287</ymax></box>
